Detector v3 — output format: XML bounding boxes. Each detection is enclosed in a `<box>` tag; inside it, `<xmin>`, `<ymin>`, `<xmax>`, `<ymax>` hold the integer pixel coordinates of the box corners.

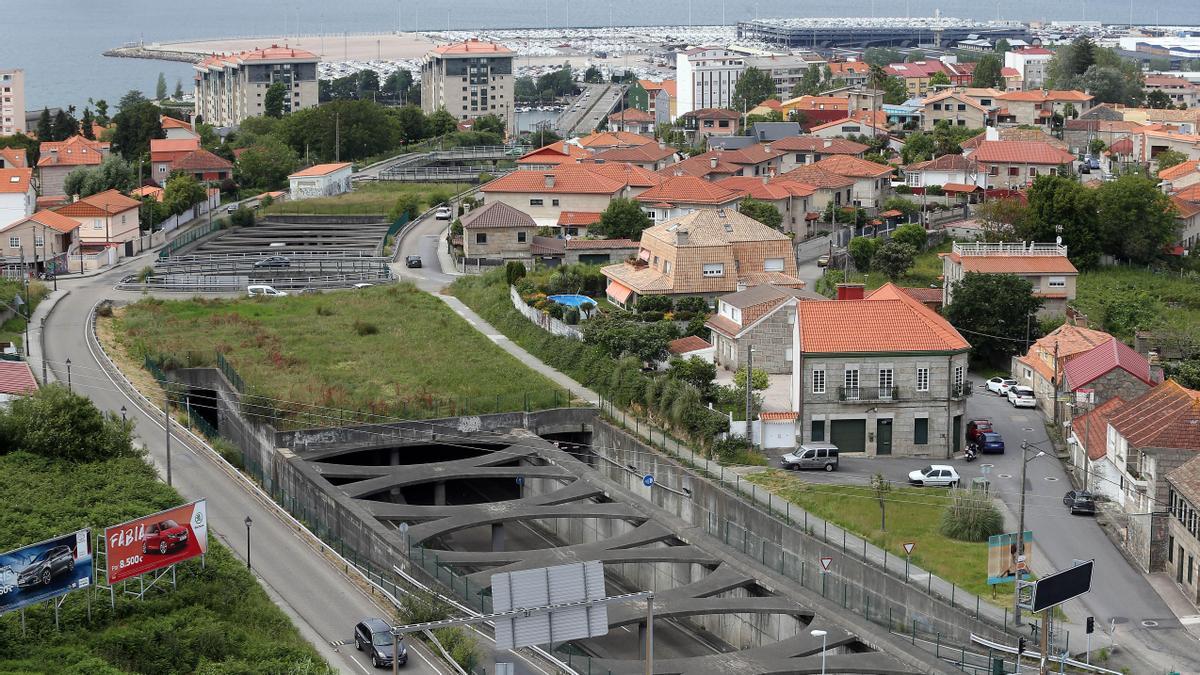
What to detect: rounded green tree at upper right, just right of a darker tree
<box><xmin>1096</xmin><ymin>174</ymin><xmax>1180</xmax><ymax>264</ymax></box>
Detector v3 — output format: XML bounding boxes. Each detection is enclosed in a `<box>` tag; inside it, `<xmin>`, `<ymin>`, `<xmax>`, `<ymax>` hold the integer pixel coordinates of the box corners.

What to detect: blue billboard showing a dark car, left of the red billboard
<box><xmin>0</xmin><ymin>530</ymin><xmax>91</xmax><ymax>614</ymax></box>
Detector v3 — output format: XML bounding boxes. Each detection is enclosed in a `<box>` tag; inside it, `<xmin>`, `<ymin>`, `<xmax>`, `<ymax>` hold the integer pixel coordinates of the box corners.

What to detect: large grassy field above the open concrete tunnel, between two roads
<box><xmin>101</xmin><ymin>283</ymin><xmax>566</xmax><ymax>428</ymax></box>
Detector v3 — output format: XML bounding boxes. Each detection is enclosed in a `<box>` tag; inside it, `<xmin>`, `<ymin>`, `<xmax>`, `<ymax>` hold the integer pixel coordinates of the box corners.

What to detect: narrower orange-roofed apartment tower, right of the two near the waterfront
<box><xmin>421</xmin><ymin>38</ymin><xmax>516</xmax><ymax>120</ymax></box>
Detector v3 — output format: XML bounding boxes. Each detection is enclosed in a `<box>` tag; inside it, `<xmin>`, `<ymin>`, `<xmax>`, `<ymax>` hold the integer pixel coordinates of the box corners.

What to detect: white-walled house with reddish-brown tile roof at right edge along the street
<box><xmin>1105</xmin><ymin>380</ymin><xmax>1200</xmax><ymax>572</ymax></box>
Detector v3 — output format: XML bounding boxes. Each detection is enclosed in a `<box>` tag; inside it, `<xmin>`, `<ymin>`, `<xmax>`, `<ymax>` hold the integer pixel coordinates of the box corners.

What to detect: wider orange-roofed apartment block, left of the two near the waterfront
<box><xmin>194</xmin><ymin>44</ymin><xmax>319</xmax><ymax>127</ymax></box>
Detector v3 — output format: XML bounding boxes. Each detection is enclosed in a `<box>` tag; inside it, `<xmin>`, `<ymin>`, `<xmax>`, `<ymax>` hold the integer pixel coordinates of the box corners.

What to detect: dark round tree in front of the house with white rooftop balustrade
<box><xmin>943</xmin><ymin>271</ymin><xmax>1042</xmax><ymax>366</ymax></box>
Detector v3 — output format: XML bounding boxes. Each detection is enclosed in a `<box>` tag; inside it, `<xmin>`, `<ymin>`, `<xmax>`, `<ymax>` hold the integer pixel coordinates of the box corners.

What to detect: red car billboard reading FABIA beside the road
<box><xmin>104</xmin><ymin>500</ymin><xmax>209</xmax><ymax>585</ymax></box>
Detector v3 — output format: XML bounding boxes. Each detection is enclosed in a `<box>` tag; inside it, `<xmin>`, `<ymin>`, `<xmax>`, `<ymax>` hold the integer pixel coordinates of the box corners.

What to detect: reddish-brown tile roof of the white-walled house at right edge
<box><xmin>1109</xmin><ymin>380</ymin><xmax>1200</xmax><ymax>452</ymax></box>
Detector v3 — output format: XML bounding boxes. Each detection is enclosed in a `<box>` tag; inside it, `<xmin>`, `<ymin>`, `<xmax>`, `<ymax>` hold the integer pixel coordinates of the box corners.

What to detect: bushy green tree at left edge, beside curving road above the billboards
<box><xmin>0</xmin><ymin>384</ymin><xmax>138</xmax><ymax>462</ymax></box>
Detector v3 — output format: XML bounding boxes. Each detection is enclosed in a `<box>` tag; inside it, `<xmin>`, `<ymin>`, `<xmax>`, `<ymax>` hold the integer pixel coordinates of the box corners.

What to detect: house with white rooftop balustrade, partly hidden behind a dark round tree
<box><xmin>941</xmin><ymin>243</ymin><xmax>1079</xmax><ymax>316</ymax></box>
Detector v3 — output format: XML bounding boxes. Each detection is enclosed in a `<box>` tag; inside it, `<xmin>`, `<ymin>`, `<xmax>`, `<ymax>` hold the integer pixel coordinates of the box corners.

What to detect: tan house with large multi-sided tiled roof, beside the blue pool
<box><xmin>601</xmin><ymin>208</ymin><xmax>804</xmax><ymax>307</ymax></box>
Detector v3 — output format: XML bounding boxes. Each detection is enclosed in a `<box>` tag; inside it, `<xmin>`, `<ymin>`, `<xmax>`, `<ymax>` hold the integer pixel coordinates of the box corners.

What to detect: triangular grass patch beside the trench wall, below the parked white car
<box><xmin>746</xmin><ymin>470</ymin><xmax>1013</xmax><ymax>598</ymax></box>
